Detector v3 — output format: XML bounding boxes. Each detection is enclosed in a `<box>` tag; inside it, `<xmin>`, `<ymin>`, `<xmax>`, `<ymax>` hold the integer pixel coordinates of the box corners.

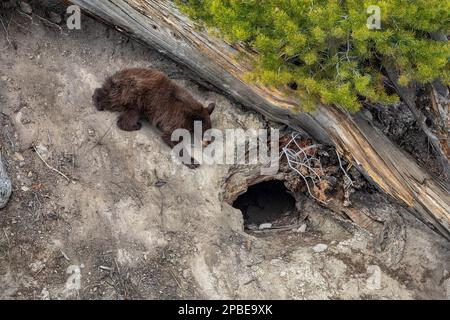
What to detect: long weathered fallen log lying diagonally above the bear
<box><xmin>72</xmin><ymin>0</ymin><xmax>450</xmax><ymax>239</ymax></box>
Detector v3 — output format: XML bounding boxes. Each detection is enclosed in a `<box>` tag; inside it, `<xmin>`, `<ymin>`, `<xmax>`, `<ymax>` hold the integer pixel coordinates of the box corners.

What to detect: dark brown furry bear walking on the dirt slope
<box><xmin>92</xmin><ymin>68</ymin><xmax>215</xmax><ymax>168</ymax></box>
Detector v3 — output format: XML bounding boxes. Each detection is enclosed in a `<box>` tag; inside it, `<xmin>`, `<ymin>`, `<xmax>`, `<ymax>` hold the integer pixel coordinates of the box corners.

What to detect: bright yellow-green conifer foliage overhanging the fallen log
<box><xmin>178</xmin><ymin>0</ymin><xmax>450</xmax><ymax>111</ymax></box>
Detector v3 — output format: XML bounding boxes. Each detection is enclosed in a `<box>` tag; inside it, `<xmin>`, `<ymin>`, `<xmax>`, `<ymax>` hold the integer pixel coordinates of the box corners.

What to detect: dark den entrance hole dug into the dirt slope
<box><xmin>233</xmin><ymin>180</ymin><xmax>296</xmax><ymax>230</ymax></box>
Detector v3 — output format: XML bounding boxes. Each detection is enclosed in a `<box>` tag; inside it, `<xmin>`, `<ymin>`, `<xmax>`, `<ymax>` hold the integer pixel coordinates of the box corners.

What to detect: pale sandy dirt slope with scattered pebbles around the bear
<box><xmin>0</xmin><ymin>3</ymin><xmax>450</xmax><ymax>299</ymax></box>
